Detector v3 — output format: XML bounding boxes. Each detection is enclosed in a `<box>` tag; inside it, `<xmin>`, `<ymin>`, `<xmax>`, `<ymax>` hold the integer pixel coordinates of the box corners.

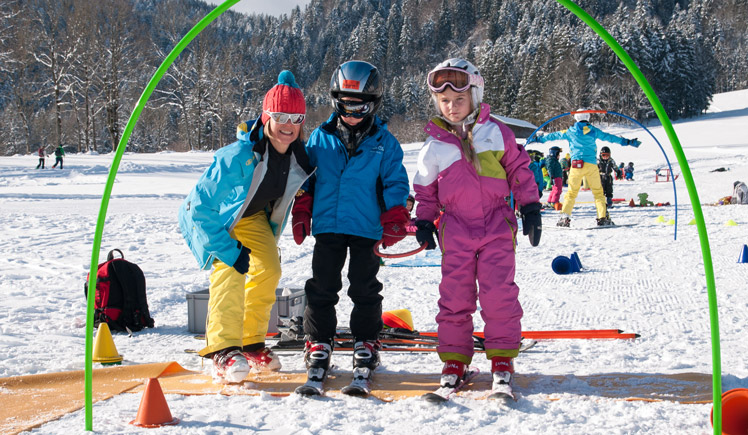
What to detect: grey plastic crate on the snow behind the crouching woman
<box><xmin>187</xmin><ymin>288</ymin><xmax>306</xmax><ymax>334</ymax></box>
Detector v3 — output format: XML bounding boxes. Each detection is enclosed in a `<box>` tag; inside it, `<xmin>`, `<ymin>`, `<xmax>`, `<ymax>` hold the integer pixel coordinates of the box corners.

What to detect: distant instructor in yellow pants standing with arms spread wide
<box><xmin>536</xmin><ymin>109</ymin><xmax>641</xmax><ymax>227</ymax></box>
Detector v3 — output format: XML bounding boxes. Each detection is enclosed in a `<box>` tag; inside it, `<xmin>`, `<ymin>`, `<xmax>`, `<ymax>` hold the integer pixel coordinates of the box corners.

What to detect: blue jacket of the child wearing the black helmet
<box><xmin>306</xmin><ymin>113</ymin><xmax>410</xmax><ymax>240</ymax></box>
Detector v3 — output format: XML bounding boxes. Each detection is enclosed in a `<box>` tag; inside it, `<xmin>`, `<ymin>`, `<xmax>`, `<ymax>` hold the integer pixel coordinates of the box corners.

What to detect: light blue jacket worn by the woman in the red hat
<box><xmin>179</xmin><ymin>118</ymin><xmax>313</xmax><ymax>270</ymax></box>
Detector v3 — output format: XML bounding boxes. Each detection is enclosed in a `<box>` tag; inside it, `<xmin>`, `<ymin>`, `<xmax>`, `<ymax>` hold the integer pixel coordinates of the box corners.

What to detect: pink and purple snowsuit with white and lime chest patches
<box><xmin>413</xmin><ymin>104</ymin><xmax>539</xmax><ymax>363</ymax></box>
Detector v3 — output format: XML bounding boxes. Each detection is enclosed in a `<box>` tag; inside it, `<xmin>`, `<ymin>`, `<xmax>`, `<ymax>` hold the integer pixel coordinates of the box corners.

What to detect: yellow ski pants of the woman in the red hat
<box><xmin>199</xmin><ymin>211</ymin><xmax>281</xmax><ymax>356</ymax></box>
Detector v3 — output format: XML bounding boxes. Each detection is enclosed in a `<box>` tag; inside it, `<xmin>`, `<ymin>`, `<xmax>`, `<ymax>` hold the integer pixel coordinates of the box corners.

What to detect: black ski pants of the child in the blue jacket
<box><xmin>304</xmin><ymin>233</ymin><xmax>382</xmax><ymax>343</ymax></box>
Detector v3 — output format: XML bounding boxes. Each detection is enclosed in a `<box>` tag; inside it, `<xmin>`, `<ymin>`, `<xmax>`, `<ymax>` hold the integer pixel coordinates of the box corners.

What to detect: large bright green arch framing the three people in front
<box><xmin>84</xmin><ymin>0</ymin><xmax>722</xmax><ymax>434</ymax></box>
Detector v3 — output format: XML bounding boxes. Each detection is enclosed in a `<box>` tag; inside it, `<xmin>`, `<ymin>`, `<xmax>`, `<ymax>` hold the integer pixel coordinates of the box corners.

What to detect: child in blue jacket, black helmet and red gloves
<box><xmin>292</xmin><ymin>60</ymin><xmax>410</xmax><ymax>394</ymax></box>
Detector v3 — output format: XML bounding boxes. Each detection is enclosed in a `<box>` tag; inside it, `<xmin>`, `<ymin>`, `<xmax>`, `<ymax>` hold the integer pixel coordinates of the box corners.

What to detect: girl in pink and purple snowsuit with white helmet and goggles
<box><xmin>413</xmin><ymin>59</ymin><xmax>541</xmax><ymax>402</ymax></box>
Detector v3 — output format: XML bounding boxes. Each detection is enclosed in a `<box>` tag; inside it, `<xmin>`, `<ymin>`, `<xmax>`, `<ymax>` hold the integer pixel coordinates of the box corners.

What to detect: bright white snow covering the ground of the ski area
<box><xmin>0</xmin><ymin>90</ymin><xmax>748</xmax><ymax>434</ymax></box>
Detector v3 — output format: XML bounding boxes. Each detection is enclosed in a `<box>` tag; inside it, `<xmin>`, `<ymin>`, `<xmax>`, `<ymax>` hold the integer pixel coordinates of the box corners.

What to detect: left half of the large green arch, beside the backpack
<box><xmin>84</xmin><ymin>0</ymin><xmax>240</xmax><ymax>431</ymax></box>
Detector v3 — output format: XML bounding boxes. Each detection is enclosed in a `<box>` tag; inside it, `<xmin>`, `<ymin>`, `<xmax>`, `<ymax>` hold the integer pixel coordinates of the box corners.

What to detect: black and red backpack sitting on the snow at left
<box><xmin>83</xmin><ymin>249</ymin><xmax>153</xmax><ymax>332</ymax></box>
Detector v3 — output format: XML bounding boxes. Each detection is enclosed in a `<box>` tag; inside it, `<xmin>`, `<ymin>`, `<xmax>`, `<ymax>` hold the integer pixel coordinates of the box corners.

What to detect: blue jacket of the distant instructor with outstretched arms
<box><xmin>537</xmin><ymin>121</ymin><xmax>641</xmax><ymax>165</ymax></box>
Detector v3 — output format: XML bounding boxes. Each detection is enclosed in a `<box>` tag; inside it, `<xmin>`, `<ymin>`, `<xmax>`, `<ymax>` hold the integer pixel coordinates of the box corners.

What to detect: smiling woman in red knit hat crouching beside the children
<box><xmin>179</xmin><ymin>71</ymin><xmax>313</xmax><ymax>383</ymax></box>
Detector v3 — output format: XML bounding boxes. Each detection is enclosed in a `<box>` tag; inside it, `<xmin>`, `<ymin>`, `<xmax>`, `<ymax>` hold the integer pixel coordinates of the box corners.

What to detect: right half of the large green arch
<box><xmin>557</xmin><ymin>0</ymin><xmax>722</xmax><ymax>435</ymax></box>
